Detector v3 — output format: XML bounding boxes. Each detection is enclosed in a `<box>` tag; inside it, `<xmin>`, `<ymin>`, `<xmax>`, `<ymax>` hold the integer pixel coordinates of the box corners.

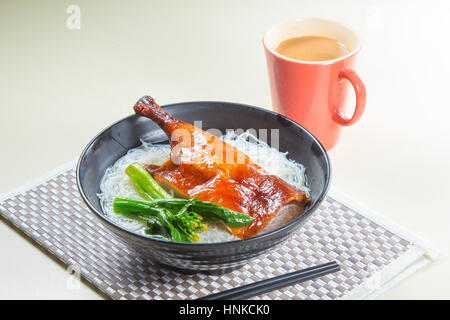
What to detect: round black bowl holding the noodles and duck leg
<box><xmin>77</xmin><ymin>102</ymin><xmax>330</xmax><ymax>273</ymax></box>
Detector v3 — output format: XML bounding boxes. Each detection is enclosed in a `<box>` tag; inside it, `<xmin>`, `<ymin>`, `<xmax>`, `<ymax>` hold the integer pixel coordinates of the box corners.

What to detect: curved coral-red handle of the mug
<box><xmin>333</xmin><ymin>69</ymin><xmax>366</xmax><ymax>126</ymax></box>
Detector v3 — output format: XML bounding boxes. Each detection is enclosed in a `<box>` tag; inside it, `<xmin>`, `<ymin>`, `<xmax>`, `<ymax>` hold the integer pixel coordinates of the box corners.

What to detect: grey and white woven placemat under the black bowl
<box><xmin>0</xmin><ymin>167</ymin><xmax>436</xmax><ymax>299</ymax></box>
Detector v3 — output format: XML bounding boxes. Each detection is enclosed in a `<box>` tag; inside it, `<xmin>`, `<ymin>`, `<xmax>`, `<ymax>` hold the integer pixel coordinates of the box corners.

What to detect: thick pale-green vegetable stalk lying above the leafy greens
<box><xmin>125</xmin><ymin>162</ymin><xmax>171</xmax><ymax>200</ymax></box>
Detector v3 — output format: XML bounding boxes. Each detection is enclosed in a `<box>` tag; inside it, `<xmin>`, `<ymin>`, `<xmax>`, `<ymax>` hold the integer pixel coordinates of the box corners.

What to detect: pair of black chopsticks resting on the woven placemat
<box><xmin>198</xmin><ymin>261</ymin><xmax>341</xmax><ymax>300</ymax></box>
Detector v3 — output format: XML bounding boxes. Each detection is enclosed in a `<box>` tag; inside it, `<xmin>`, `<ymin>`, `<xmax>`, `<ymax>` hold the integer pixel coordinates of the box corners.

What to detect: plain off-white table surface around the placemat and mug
<box><xmin>0</xmin><ymin>0</ymin><xmax>450</xmax><ymax>299</ymax></box>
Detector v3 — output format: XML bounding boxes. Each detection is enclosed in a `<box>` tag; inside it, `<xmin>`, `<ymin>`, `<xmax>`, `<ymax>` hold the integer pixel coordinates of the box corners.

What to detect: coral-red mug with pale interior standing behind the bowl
<box><xmin>263</xmin><ymin>18</ymin><xmax>366</xmax><ymax>150</ymax></box>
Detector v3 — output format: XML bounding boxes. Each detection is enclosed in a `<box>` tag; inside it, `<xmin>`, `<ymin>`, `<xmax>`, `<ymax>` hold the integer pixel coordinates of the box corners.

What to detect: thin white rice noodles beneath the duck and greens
<box><xmin>97</xmin><ymin>131</ymin><xmax>309</xmax><ymax>242</ymax></box>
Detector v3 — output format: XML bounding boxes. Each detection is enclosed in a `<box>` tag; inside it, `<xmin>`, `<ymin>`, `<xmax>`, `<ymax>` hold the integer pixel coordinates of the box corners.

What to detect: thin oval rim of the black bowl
<box><xmin>76</xmin><ymin>101</ymin><xmax>331</xmax><ymax>249</ymax></box>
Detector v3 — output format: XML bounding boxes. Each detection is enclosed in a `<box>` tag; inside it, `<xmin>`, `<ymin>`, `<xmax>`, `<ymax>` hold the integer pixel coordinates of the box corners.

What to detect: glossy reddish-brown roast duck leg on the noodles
<box><xmin>134</xmin><ymin>96</ymin><xmax>309</xmax><ymax>239</ymax></box>
